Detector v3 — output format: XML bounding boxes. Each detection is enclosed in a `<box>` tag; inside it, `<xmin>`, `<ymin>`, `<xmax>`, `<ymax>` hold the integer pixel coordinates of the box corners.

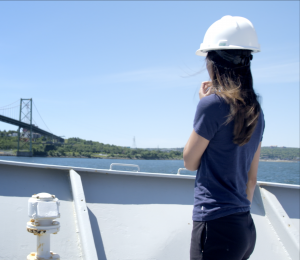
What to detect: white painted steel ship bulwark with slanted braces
<box><xmin>0</xmin><ymin>161</ymin><xmax>300</xmax><ymax>260</ymax></box>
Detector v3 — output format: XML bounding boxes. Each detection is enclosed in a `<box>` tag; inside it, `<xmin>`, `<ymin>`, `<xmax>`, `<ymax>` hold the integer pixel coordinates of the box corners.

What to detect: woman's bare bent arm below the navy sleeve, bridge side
<box><xmin>183</xmin><ymin>130</ymin><xmax>209</xmax><ymax>171</ymax></box>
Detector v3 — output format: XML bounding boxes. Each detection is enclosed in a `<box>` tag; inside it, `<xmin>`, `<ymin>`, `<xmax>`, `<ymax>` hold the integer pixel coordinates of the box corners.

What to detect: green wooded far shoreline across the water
<box><xmin>0</xmin><ymin>130</ymin><xmax>300</xmax><ymax>160</ymax></box>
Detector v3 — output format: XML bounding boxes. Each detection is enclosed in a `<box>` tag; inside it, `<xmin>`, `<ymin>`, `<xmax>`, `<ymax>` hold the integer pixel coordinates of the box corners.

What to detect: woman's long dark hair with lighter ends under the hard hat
<box><xmin>206</xmin><ymin>50</ymin><xmax>261</xmax><ymax>146</ymax></box>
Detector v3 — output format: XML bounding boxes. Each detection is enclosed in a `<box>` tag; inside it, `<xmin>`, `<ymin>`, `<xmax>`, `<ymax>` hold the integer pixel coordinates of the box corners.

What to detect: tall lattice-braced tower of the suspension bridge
<box><xmin>17</xmin><ymin>98</ymin><xmax>32</xmax><ymax>157</ymax></box>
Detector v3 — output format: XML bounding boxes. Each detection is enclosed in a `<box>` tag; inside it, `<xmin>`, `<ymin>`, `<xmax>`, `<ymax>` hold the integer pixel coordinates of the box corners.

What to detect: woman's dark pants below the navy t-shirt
<box><xmin>190</xmin><ymin>211</ymin><xmax>256</xmax><ymax>260</ymax></box>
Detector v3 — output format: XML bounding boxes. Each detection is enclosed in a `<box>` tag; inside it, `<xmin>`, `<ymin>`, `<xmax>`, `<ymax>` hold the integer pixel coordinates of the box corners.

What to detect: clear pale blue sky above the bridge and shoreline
<box><xmin>0</xmin><ymin>1</ymin><xmax>299</xmax><ymax>148</ymax></box>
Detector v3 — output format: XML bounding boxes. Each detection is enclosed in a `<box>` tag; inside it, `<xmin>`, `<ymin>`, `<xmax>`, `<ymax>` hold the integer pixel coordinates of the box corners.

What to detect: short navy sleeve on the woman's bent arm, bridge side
<box><xmin>194</xmin><ymin>94</ymin><xmax>228</xmax><ymax>141</ymax></box>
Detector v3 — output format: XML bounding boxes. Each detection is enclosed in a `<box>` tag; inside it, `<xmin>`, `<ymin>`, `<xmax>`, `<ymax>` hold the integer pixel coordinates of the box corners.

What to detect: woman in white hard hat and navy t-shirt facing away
<box><xmin>183</xmin><ymin>16</ymin><xmax>264</xmax><ymax>260</ymax></box>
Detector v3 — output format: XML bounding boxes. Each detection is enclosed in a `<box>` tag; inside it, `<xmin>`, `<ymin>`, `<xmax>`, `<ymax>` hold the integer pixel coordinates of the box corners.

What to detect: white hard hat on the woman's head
<box><xmin>196</xmin><ymin>15</ymin><xmax>260</xmax><ymax>56</ymax></box>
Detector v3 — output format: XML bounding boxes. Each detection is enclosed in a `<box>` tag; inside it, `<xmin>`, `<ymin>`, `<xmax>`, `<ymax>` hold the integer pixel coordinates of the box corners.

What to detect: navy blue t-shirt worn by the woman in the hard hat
<box><xmin>193</xmin><ymin>94</ymin><xmax>264</xmax><ymax>221</ymax></box>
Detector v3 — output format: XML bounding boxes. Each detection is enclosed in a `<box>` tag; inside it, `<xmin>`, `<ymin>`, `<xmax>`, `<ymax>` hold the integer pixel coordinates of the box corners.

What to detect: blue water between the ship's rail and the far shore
<box><xmin>0</xmin><ymin>156</ymin><xmax>300</xmax><ymax>185</ymax></box>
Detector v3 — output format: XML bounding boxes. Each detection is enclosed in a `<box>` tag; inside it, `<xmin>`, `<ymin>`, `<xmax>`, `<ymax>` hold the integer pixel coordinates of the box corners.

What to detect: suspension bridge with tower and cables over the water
<box><xmin>0</xmin><ymin>98</ymin><xmax>64</xmax><ymax>156</ymax></box>
